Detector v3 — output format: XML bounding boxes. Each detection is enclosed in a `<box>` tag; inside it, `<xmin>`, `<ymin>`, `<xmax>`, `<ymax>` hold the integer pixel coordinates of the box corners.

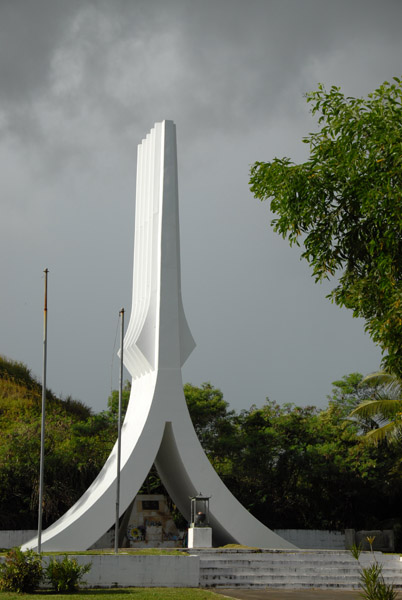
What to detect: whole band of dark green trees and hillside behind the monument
<box><xmin>0</xmin><ymin>358</ymin><xmax>402</xmax><ymax>540</ymax></box>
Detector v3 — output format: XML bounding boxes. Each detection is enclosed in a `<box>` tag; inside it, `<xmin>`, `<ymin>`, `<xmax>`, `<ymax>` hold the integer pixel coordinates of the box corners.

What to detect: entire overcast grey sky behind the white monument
<box><xmin>0</xmin><ymin>0</ymin><xmax>402</xmax><ymax>411</ymax></box>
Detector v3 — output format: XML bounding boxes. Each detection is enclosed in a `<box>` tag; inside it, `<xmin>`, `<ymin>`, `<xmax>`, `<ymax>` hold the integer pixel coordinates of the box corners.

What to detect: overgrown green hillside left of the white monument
<box><xmin>0</xmin><ymin>356</ymin><xmax>115</xmax><ymax>529</ymax></box>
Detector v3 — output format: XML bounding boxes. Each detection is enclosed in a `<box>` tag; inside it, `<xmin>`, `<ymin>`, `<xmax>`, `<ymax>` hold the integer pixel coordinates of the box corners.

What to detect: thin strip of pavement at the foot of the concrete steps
<box><xmin>209</xmin><ymin>588</ymin><xmax>402</xmax><ymax>600</ymax></box>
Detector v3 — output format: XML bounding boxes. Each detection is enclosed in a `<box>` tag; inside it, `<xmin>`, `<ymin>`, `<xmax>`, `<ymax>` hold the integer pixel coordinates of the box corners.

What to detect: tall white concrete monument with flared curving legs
<box><xmin>25</xmin><ymin>121</ymin><xmax>295</xmax><ymax>551</ymax></box>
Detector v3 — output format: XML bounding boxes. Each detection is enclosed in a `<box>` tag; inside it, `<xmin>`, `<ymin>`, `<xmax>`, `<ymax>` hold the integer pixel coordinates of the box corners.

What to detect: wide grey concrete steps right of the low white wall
<box><xmin>192</xmin><ymin>549</ymin><xmax>402</xmax><ymax>589</ymax></box>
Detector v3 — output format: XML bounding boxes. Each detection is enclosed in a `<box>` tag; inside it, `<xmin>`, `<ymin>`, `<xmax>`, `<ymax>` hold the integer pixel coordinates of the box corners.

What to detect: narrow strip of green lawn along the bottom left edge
<box><xmin>0</xmin><ymin>588</ymin><xmax>222</xmax><ymax>600</ymax></box>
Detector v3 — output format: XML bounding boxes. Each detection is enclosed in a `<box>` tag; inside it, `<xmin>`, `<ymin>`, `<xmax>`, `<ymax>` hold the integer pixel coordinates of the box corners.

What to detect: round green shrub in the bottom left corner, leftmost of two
<box><xmin>0</xmin><ymin>548</ymin><xmax>43</xmax><ymax>592</ymax></box>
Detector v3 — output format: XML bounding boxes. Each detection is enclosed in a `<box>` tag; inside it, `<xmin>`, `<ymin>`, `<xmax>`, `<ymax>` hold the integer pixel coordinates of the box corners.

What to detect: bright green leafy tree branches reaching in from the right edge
<box><xmin>250</xmin><ymin>77</ymin><xmax>402</xmax><ymax>377</ymax></box>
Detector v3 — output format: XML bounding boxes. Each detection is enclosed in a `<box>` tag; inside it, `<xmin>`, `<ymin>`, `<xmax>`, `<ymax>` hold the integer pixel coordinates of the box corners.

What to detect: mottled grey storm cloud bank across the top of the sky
<box><xmin>0</xmin><ymin>0</ymin><xmax>402</xmax><ymax>144</ymax></box>
